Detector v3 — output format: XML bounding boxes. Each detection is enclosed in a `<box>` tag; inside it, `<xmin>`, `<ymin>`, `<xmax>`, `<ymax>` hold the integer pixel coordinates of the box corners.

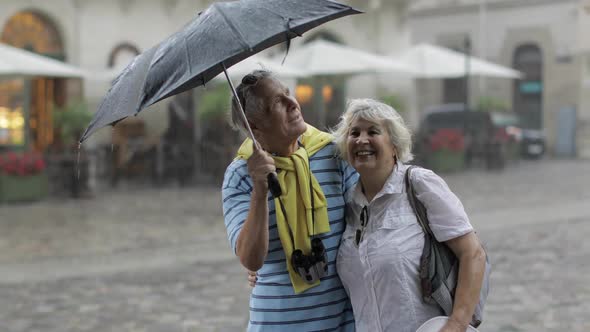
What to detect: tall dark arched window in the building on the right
<box><xmin>512</xmin><ymin>44</ymin><xmax>543</xmax><ymax>129</ymax></box>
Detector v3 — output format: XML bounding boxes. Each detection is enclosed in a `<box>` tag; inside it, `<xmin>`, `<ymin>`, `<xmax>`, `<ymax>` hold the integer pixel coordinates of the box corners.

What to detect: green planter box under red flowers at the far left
<box><xmin>0</xmin><ymin>173</ymin><xmax>47</xmax><ymax>203</ymax></box>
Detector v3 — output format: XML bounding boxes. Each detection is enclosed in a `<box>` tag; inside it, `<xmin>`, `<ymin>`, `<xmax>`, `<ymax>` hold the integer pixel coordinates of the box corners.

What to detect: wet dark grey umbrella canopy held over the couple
<box><xmin>80</xmin><ymin>0</ymin><xmax>360</xmax><ymax>142</ymax></box>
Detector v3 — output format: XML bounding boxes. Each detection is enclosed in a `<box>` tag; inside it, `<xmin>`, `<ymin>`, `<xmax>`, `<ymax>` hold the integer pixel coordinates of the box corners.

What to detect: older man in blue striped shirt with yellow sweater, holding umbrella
<box><xmin>222</xmin><ymin>70</ymin><xmax>357</xmax><ymax>331</ymax></box>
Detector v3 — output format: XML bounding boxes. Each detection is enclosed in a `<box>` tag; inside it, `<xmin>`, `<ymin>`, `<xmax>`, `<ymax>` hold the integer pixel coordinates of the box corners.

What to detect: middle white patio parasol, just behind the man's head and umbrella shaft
<box><xmin>274</xmin><ymin>39</ymin><xmax>412</xmax><ymax>76</ymax></box>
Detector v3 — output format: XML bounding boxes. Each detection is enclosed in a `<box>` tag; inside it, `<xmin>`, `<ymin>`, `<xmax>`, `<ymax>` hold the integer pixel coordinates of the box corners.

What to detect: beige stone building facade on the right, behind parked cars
<box><xmin>409</xmin><ymin>0</ymin><xmax>590</xmax><ymax>157</ymax></box>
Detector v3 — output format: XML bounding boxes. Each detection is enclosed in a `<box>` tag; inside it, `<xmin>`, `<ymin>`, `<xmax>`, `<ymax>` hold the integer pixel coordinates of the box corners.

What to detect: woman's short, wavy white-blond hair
<box><xmin>332</xmin><ymin>99</ymin><xmax>414</xmax><ymax>163</ymax></box>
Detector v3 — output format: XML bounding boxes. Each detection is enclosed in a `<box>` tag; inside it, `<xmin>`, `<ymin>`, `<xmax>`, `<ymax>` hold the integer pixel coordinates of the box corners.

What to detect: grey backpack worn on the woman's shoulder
<box><xmin>404</xmin><ymin>166</ymin><xmax>492</xmax><ymax>327</ymax></box>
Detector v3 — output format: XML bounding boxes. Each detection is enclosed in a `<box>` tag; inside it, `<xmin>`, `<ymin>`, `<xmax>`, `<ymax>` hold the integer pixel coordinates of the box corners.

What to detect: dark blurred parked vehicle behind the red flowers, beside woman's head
<box><xmin>415</xmin><ymin>104</ymin><xmax>513</xmax><ymax>169</ymax></box>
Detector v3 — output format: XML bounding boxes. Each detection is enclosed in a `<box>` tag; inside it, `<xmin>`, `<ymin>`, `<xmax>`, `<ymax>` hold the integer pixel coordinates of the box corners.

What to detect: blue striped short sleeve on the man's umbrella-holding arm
<box><xmin>221</xmin><ymin>160</ymin><xmax>252</xmax><ymax>254</ymax></box>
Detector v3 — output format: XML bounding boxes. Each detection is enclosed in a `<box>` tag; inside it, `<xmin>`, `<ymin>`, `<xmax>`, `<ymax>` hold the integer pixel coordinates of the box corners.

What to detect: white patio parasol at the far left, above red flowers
<box><xmin>0</xmin><ymin>43</ymin><xmax>84</xmax><ymax>77</ymax></box>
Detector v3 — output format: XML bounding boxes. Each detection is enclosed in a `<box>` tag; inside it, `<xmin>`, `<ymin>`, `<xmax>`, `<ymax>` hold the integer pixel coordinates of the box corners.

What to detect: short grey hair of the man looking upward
<box><xmin>231</xmin><ymin>69</ymin><xmax>274</xmax><ymax>136</ymax></box>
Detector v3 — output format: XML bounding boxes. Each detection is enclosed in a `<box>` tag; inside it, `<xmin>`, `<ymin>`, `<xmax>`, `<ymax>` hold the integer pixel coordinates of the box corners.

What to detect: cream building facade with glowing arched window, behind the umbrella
<box><xmin>0</xmin><ymin>0</ymin><xmax>410</xmax><ymax>152</ymax></box>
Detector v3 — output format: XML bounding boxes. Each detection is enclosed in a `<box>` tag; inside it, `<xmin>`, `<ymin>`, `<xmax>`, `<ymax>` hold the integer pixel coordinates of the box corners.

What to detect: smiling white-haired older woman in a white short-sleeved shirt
<box><xmin>334</xmin><ymin>99</ymin><xmax>485</xmax><ymax>332</ymax></box>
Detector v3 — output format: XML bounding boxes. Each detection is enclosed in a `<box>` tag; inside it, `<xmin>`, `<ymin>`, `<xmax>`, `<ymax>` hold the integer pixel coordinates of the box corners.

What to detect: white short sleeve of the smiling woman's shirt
<box><xmin>412</xmin><ymin>168</ymin><xmax>473</xmax><ymax>242</ymax></box>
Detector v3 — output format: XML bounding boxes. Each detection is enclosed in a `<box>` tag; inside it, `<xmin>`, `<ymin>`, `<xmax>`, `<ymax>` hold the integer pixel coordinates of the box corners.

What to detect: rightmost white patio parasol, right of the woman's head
<box><xmin>394</xmin><ymin>44</ymin><xmax>522</xmax><ymax>78</ymax></box>
